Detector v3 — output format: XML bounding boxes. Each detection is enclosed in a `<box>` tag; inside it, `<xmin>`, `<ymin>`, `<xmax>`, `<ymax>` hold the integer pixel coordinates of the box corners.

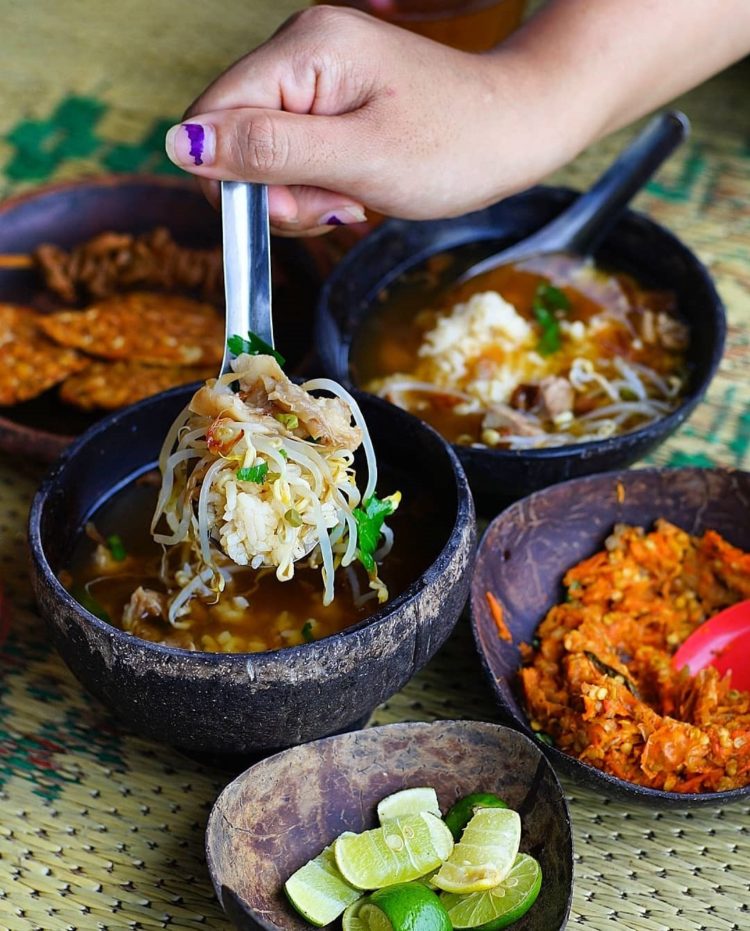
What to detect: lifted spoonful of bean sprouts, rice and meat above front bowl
<box><xmin>152</xmin><ymin>354</ymin><xmax>399</xmax><ymax>626</ymax></box>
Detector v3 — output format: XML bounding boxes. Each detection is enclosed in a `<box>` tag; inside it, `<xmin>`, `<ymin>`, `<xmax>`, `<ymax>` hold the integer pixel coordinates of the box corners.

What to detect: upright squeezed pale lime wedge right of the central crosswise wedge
<box><xmin>432</xmin><ymin>808</ymin><xmax>521</xmax><ymax>895</ymax></box>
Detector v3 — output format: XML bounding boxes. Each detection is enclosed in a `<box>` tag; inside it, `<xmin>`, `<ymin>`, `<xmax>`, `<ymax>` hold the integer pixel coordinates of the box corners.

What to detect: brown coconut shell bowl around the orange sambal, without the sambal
<box><xmin>471</xmin><ymin>468</ymin><xmax>750</xmax><ymax>808</ymax></box>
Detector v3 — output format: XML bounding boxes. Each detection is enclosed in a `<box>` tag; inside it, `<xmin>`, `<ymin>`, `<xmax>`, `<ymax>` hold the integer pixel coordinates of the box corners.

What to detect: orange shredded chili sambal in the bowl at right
<box><xmin>520</xmin><ymin>520</ymin><xmax>750</xmax><ymax>793</ymax></box>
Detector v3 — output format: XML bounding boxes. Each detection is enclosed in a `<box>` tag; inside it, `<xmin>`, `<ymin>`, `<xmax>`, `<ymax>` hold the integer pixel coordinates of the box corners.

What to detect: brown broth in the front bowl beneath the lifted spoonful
<box><xmin>67</xmin><ymin>470</ymin><xmax>450</xmax><ymax>653</ymax></box>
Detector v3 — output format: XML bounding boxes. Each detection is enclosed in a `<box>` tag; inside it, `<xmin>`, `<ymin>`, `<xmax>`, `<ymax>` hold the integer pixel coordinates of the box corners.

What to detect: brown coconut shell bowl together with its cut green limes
<box><xmin>206</xmin><ymin>721</ymin><xmax>573</xmax><ymax>931</ymax></box>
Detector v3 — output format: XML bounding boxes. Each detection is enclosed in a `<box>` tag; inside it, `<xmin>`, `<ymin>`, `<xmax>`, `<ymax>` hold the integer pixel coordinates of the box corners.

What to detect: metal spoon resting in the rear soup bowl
<box><xmin>458</xmin><ymin>110</ymin><xmax>690</xmax><ymax>284</ymax></box>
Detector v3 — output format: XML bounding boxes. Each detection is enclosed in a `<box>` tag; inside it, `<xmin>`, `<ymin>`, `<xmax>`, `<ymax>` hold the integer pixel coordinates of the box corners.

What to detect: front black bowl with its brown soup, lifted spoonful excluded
<box><xmin>29</xmin><ymin>389</ymin><xmax>475</xmax><ymax>753</ymax></box>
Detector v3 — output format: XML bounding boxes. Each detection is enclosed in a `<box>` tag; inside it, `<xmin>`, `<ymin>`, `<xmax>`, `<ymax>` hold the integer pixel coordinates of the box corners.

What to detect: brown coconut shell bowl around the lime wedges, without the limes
<box><xmin>206</xmin><ymin>721</ymin><xmax>573</xmax><ymax>931</ymax></box>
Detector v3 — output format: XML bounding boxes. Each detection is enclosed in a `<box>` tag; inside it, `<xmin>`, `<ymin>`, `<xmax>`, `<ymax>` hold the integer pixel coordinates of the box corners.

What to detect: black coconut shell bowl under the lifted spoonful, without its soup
<box><xmin>29</xmin><ymin>386</ymin><xmax>475</xmax><ymax>754</ymax></box>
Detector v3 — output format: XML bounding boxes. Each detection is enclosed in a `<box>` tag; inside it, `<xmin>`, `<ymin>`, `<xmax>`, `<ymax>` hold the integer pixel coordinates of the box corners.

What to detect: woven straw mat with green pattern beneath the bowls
<box><xmin>0</xmin><ymin>0</ymin><xmax>750</xmax><ymax>931</ymax></box>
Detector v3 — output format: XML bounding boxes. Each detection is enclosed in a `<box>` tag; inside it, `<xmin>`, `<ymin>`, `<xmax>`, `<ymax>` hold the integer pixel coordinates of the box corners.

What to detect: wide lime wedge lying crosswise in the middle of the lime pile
<box><xmin>333</xmin><ymin>811</ymin><xmax>453</xmax><ymax>891</ymax></box>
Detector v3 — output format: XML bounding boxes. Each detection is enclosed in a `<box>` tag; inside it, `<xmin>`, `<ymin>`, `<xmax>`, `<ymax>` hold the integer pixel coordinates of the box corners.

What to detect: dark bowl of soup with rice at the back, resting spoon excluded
<box><xmin>318</xmin><ymin>188</ymin><xmax>726</xmax><ymax>509</ymax></box>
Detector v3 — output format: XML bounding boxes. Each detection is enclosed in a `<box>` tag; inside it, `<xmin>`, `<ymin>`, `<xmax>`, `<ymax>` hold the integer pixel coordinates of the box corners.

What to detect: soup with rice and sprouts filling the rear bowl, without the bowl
<box><xmin>351</xmin><ymin>256</ymin><xmax>688</xmax><ymax>449</ymax></box>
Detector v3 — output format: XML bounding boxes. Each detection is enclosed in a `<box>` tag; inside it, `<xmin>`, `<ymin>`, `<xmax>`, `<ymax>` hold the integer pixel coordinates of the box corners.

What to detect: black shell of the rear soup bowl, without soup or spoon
<box><xmin>317</xmin><ymin>187</ymin><xmax>726</xmax><ymax>514</ymax></box>
